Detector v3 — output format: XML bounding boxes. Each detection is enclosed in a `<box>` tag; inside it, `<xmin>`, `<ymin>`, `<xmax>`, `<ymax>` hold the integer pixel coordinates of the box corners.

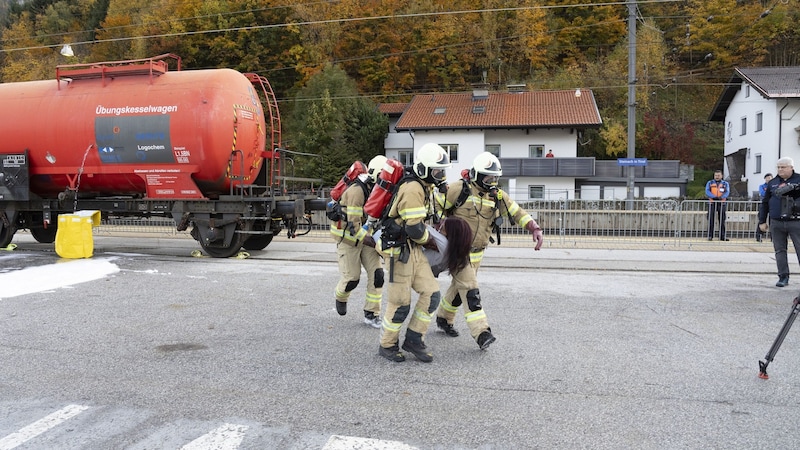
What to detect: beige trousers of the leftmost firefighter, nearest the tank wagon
<box><xmin>334</xmin><ymin>242</ymin><xmax>383</xmax><ymax>316</ymax></box>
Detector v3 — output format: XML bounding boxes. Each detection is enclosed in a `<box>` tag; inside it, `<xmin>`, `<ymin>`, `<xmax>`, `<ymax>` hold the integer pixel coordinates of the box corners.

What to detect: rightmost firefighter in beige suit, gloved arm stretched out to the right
<box><xmin>436</xmin><ymin>152</ymin><xmax>543</xmax><ymax>350</ymax></box>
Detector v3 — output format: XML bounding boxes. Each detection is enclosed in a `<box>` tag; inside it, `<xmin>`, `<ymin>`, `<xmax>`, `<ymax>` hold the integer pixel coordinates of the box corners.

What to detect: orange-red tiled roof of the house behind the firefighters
<box><xmin>395</xmin><ymin>90</ymin><xmax>603</xmax><ymax>130</ymax></box>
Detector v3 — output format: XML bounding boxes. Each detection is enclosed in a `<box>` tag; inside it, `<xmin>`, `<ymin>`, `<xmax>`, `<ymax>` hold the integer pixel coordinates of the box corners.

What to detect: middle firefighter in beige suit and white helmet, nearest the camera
<box><xmin>377</xmin><ymin>143</ymin><xmax>450</xmax><ymax>362</ymax></box>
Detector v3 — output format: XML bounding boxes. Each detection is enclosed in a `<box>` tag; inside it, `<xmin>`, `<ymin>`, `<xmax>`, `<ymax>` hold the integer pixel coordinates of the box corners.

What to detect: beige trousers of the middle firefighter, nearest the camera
<box><xmin>381</xmin><ymin>245</ymin><xmax>439</xmax><ymax>348</ymax></box>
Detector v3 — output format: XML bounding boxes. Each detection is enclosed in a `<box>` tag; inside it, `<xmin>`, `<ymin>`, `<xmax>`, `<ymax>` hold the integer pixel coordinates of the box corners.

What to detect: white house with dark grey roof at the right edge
<box><xmin>710</xmin><ymin>66</ymin><xmax>800</xmax><ymax>197</ymax></box>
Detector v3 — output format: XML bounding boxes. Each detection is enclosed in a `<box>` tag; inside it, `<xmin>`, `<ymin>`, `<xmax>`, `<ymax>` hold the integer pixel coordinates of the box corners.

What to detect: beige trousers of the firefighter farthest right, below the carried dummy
<box><xmin>436</xmin><ymin>261</ymin><xmax>489</xmax><ymax>339</ymax></box>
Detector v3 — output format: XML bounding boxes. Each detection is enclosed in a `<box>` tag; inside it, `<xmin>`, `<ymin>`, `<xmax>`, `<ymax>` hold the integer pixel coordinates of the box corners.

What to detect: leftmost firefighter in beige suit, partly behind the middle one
<box><xmin>331</xmin><ymin>155</ymin><xmax>386</xmax><ymax>328</ymax></box>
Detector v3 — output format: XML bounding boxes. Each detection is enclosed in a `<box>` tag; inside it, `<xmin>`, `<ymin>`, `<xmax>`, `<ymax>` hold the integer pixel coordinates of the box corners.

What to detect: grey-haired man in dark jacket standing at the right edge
<box><xmin>758</xmin><ymin>158</ymin><xmax>800</xmax><ymax>287</ymax></box>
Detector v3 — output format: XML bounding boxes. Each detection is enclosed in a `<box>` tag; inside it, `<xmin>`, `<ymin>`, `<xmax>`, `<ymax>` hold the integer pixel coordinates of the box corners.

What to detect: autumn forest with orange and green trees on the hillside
<box><xmin>0</xmin><ymin>0</ymin><xmax>800</xmax><ymax>186</ymax></box>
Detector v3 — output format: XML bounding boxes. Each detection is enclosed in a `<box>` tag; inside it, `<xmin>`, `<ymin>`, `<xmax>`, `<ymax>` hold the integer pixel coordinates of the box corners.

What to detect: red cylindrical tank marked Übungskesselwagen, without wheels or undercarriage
<box><xmin>0</xmin><ymin>55</ymin><xmax>271</xmax><ymax>199</ymax></box>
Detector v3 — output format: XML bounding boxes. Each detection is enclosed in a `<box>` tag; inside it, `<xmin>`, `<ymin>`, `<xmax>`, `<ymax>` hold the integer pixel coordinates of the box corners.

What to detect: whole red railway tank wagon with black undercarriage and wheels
<box><xmin>0</xmin><ymin>55</ymin><xmax>325</xmax><ymax>257</ymax></box>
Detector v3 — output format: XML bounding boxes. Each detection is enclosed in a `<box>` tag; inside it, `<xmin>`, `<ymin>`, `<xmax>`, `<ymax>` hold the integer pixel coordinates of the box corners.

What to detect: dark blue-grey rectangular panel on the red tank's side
<box><xmin>94</xmin><ymin>114</ymin><xmax>175</xmax><ymax>164</ymax></box>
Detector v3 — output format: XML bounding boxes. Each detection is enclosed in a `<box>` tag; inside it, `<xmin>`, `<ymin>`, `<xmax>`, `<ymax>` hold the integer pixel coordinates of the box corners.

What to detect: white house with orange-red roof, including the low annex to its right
<box><xmin>379</xmin><ymin>86</ymin><xmax>687</xmax><ymax>201</ymax></box>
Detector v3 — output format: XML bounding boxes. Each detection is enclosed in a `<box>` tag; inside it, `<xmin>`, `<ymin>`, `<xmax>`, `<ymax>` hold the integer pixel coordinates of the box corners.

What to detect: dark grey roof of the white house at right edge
<box><xmin>709</xmin><ymin>66</ymin><xmax>800</xmax><ymax>122</ymax></box>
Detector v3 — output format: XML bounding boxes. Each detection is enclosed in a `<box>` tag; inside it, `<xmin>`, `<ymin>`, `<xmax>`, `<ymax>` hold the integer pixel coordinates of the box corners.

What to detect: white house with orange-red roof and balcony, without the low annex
<box><xmin>382</xmin><ymin>89</ymin><xmax>602</xmax><ymax>200</ymax></box>
